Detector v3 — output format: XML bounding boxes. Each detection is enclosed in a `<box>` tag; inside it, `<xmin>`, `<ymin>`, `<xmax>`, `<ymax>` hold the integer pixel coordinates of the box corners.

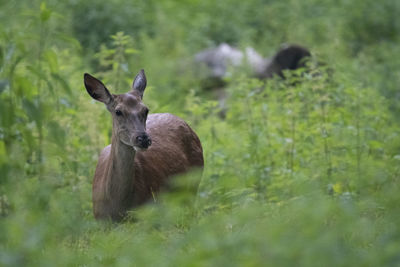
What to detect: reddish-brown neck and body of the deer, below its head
<box><xmin>93</xmin><ymin>113</ymin><xmax>204</xmax><ymax>221</ymax></box>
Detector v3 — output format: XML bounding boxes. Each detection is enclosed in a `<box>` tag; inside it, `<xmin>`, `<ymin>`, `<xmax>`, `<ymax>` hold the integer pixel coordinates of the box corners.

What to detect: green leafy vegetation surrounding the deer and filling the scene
<box><xmin>0</xmin><ymin>0</ymin><xmax>400</xmax><ymax>266</ymax></box>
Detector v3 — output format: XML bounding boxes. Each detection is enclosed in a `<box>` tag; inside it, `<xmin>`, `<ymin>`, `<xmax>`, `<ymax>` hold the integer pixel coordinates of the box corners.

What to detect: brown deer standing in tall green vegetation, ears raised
<box><xmin>84</xmin><ymin>70</ymin><xmax>204</xmax><ymax>221</ymax></box>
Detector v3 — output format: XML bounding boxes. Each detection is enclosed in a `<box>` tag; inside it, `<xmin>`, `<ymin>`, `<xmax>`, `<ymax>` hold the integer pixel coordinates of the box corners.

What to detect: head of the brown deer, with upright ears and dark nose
<box><xmin>84</xmin><ymin>70</ymin><xmax>151</xmax><ymax>151</ymax></box>
